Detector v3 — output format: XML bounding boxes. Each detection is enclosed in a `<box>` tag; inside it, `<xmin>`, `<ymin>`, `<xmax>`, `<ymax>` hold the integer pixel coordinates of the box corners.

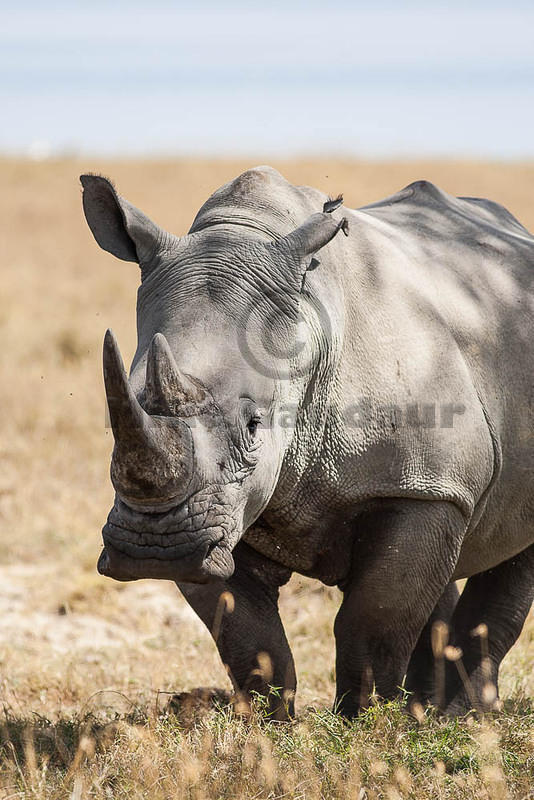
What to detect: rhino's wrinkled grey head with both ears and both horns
<box><xmin>81</xmin><ymin>170</ymin><xmax>346</xmax><ymax>583</ymax></box>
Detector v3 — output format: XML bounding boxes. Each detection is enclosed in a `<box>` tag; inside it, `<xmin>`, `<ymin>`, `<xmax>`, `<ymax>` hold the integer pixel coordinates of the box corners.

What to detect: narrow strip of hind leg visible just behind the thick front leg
<box><xmin>405</xmin><ymin>582</ymin><xmax>459</xmax><ymax>705</ymax></box>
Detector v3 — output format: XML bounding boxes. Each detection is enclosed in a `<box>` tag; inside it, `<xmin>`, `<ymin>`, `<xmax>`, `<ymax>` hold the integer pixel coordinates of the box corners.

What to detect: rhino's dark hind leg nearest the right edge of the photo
<box><xmin>444</xmin><ymin>545</ymin><xmax>534</xmax><ymax>716</ymax></box>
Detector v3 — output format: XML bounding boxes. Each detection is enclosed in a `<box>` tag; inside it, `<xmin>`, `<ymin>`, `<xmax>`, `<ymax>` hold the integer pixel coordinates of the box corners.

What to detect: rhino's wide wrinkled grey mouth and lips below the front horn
<box><xmin>101</xmin><ymin>500</ymin><xmax>239</xmax><ymax>583</ymax></box>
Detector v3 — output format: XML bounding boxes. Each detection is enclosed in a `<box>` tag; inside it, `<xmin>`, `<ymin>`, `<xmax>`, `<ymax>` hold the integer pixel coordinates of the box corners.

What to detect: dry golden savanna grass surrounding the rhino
<box><xmin>0</xmin><ymin>160</ymin><xmax>534</xmax><ymax>800</ymax></box>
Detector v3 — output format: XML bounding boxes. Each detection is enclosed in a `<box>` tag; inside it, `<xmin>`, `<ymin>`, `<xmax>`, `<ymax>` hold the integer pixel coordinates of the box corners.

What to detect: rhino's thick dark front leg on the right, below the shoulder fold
<box><xmin>334</xmin><ymin>500</ymin><xmax>465</xmax><ymax>717</ymax></box>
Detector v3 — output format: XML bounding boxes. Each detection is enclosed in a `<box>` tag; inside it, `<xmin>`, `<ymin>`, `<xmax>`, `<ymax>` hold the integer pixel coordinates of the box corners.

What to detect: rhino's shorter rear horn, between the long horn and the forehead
<box><xmin>145</xmin><ymin>333</ymin><xmax>205</xmax><ymax>416</ymax></box>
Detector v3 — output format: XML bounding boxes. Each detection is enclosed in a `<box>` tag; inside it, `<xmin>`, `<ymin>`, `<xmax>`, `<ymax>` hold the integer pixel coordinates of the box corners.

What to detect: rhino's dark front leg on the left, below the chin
<box><xmin>178</xmin><ymin>542</ymin><xmax>297</xmax><ymax>720</ymax></box>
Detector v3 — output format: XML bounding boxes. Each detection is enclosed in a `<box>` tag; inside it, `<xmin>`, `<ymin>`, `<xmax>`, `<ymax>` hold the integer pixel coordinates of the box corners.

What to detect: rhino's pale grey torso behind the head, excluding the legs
<box><xmin>253</xmin><ymin>182</ymin><xmax>534</xmax><ymax>577</ymax></box>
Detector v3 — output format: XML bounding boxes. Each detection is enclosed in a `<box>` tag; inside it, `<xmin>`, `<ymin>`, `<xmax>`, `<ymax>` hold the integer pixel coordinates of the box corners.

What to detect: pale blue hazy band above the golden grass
<box><xmin>4</xmin><ymin>0</ymin><xmax>534</xmax><ymax>160</ymax></box>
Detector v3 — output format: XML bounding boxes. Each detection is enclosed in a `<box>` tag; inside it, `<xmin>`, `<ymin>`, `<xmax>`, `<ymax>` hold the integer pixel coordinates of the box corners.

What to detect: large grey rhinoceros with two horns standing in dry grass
<box><xmin>81</xmin><ymin>167</ymin><xmax>534</xmax><ymax>719</ymax></box>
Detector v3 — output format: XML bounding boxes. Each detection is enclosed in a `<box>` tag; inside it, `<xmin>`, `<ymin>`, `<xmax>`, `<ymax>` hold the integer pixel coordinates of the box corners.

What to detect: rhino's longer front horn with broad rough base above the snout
<box><xmin>104</xmin><ymin>330</ymin><xmax>193</xmax><ymax>505</ymax></box>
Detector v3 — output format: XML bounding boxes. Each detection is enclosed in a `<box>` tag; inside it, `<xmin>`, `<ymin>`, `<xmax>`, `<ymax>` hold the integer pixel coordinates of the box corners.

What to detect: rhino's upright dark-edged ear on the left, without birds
<box><xmin>80</xmin><ymin>175</ymin><xmax>164</xmax><ymax>264</ymax></box>
